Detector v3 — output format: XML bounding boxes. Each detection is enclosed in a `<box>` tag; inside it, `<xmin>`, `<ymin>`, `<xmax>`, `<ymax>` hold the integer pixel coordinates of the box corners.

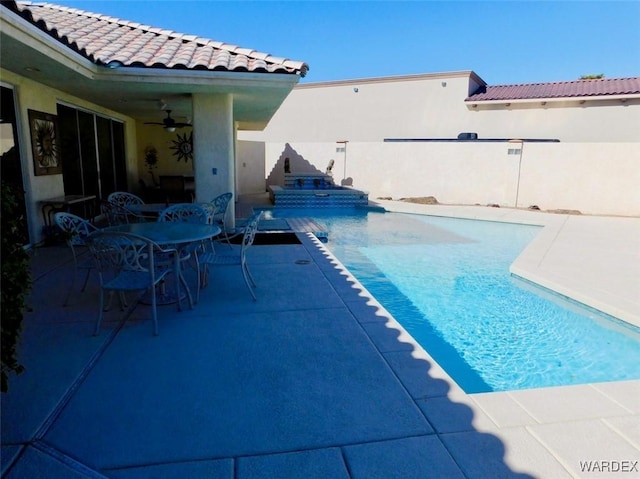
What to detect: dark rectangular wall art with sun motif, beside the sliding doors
<box><xmin>29</xmin><ymin>110</ymin><xmax>62</xmax><ymax>176</ymax></box>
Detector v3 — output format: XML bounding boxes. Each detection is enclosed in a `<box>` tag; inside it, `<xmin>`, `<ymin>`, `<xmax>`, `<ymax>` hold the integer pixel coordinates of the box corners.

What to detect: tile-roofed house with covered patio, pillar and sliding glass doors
<box><xmin>0</xmin><ymin>1</ymin><xmax>309</xmax><ymax>245</ymax></box>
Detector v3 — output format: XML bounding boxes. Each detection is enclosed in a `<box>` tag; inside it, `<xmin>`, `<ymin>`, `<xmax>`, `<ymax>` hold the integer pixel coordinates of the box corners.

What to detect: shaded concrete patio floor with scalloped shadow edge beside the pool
<box><xmin>2</xmin><ymin>227</ymin><xmax>531</xmax><ymax>479</ymax></box>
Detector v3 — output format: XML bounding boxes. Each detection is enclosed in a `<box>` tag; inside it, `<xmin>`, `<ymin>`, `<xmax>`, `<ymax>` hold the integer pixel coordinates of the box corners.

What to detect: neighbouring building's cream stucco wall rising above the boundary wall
<box><xmin>240</xmin><ymin>72</ymin><xmax>640</xmax><ymax>142</ymax></box>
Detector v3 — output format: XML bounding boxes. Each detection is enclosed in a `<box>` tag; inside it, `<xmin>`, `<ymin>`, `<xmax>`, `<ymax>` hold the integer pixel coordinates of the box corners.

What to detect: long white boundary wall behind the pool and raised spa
<box><xmin>265</xmin><ymin>142</ymin><xmax>640</xmax><ymax>216</ymax></box>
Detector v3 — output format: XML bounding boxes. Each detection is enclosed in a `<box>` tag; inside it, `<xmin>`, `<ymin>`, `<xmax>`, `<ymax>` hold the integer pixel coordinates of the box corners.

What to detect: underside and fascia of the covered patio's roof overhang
<box><xmin>0</xmin><ymin>0</ymin><xmax>306</xmax><ymax>129</ymax></box>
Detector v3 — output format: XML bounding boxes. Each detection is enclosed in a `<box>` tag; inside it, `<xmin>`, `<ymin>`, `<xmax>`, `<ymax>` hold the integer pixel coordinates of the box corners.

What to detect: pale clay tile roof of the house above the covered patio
<box><xmin>2</xmin><ymin>1</ymin><xmax>309</xmax><ymax>77</ymax></box>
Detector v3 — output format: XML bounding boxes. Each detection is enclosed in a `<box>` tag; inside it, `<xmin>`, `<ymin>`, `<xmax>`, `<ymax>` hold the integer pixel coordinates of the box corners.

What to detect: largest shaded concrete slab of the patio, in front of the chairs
<box><xmin>45</xmin><ymin>309</ymin><xmax>430</xmax><ymax>468</ymax></box>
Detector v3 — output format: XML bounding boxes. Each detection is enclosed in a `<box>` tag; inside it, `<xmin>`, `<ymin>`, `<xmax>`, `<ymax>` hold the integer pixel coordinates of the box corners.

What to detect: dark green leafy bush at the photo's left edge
<box><xmin>0</xmin><ymin>183</ymin><xmax>31</xmax><ymax>392</ymax></box>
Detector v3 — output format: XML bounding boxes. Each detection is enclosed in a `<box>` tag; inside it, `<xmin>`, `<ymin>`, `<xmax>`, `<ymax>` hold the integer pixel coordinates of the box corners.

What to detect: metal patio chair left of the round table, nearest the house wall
<box><xmin>53</xmin><ymin>212</ymin><xmax>98</xmax><ymax>306</ymax></box>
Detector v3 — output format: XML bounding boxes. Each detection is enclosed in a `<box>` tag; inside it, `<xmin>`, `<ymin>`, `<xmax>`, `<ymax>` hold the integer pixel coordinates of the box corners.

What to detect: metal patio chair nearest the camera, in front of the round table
<box><xmin>86</xmin><ymin>231</ymin><xmax>186</xmax><ymax>335</ymax></box>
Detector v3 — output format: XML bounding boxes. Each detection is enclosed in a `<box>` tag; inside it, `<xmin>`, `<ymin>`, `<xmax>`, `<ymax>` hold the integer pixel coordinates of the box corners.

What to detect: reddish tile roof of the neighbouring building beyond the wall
<box><xmin>465</xmin><ymin>77</ymin><xmax>640</xmax><ymax>102</ymax></box>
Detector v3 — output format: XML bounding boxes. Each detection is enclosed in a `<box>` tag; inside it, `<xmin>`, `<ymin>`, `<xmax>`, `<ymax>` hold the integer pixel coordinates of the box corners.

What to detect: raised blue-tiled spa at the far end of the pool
<box><xmin>268</xmin><ymin>173</ymin><xmax>369</xmax><ymax>208</ymax></box>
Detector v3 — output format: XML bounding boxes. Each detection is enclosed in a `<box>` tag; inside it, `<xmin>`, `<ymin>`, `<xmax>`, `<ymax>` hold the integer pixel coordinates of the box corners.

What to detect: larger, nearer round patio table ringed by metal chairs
<box><xmin>104</xmin><ymin>221</ymin><xmax>222</xmax><ymax>305</ymax></box>
